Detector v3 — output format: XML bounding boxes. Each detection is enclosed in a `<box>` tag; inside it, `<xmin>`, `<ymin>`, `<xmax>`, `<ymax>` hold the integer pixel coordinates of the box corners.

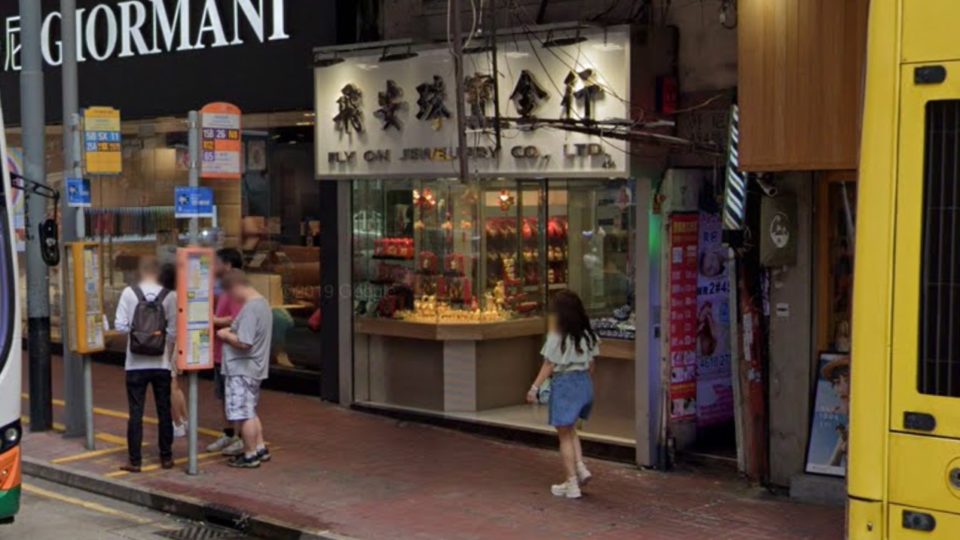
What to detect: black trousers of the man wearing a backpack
<box><xmin>127</xmin><ymin>369</ymin><xmax>173</xmax><ymax>466</ymax></box>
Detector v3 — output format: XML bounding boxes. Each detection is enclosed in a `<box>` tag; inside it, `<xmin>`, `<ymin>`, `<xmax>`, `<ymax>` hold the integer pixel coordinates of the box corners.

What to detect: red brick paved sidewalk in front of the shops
<box><xmin>18</xmin><ymin>358</ymin><xmax>843</xmax><ymax>540</ymax></box>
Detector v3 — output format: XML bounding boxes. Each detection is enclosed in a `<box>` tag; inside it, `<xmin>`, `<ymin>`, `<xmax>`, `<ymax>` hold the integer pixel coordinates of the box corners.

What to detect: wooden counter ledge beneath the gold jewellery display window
<box><xmin>354</xmin><ymin>317</ymin><xmax>546</xmax><ymax>341</ymax></box>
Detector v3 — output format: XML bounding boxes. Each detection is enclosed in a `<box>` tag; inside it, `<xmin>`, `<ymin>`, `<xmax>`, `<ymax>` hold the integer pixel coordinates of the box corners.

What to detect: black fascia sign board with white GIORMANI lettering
<box><xmin>0</xmin><ymin>0</ymin><xmax>349</xmax><ymax>124</ymax></box>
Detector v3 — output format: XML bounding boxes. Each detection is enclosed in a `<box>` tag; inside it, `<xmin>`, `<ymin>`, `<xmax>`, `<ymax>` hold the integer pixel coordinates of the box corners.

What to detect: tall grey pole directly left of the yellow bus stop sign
<box><xmin>60</xmin><ymin>0</ymin><xmax>86</xmax><ymax>437</ymax></box>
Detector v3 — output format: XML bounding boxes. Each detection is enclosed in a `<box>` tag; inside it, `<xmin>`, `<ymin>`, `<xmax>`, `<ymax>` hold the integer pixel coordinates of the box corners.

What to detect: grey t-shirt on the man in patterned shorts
<box><xmin>223</xmin><ymin>298</ymin><xmax>273</xmax><ymax>381</ymax></box>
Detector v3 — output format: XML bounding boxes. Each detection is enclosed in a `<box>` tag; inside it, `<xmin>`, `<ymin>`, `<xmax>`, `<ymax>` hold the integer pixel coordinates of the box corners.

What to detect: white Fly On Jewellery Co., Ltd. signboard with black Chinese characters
<box><xmin>315</xmin><ymin>28</ymin><xmax>632</xmax><ymax>179</ymax></box>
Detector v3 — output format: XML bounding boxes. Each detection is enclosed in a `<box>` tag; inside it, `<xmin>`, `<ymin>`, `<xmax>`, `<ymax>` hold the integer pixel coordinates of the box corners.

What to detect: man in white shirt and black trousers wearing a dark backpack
<box><xmin>115</xmin><ymin>257</ymin><xmax>177</xmax><ymax>473</ymax></box>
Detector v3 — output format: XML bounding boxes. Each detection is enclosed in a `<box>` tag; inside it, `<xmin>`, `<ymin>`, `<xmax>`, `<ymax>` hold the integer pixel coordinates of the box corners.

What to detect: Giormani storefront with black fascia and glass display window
<box><xmin>0</xmin><ymin>0</ymin><xmax>350</xmax><ymax>399</ymax></box>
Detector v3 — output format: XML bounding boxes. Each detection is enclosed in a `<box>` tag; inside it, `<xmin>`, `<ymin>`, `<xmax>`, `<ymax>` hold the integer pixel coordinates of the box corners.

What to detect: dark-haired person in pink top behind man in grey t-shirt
<box><xmin>207</xmin><ymin>248</ymin><xmax>243</xmax><ymax>456</ymax></box>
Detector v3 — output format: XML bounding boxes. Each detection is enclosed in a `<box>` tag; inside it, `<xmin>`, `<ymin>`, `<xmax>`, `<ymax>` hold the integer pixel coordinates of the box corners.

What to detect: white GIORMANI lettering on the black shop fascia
<box><xmin>3</xmin><ymin>0</ymin><xmax>290</xmax><ymax>71</ymax></box>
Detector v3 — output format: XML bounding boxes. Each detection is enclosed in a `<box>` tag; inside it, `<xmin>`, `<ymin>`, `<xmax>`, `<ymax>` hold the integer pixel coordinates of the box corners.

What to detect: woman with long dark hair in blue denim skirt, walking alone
<box><xmin>527</xmin><ymin>290</ymin><xmax>600</xmax><ymax>499</ymax></box>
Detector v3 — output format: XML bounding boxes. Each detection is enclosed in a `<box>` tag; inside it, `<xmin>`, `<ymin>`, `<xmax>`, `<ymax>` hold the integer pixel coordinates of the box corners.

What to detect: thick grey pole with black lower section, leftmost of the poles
<box><xmin>20</xmin><ymin>0</ymin><xmax>53</xmax><ymax>431</ymax></box>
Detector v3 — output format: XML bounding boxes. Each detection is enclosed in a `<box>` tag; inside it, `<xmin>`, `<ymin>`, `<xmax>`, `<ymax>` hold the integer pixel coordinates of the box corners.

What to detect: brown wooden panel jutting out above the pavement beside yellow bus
<box><xmin>738</xmin><ymin>0</ymin><xmax>868</xmax><ymax>172</ymax></box>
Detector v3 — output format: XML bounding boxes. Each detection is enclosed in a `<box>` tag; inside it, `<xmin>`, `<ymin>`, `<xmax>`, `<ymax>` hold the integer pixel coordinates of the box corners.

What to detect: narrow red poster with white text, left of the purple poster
<box><xmin>670</xmin><ymin>214</ymin><xmax>699</xmax><ymax>420</ymax></box>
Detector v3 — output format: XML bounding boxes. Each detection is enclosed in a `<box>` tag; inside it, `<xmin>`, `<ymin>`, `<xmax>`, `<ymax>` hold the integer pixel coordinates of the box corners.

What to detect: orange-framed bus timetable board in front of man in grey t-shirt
<box><xmin>177</xmin><ymin>248</ymin><xmax>214</xmax><ymax>371</ymax></box>
